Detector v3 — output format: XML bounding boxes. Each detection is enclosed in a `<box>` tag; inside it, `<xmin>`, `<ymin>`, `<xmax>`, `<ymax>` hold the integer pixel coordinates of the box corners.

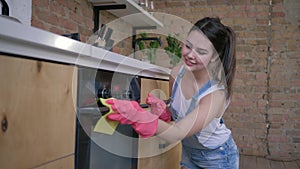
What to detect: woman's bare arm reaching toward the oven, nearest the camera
<box><xmin>156</xmin><ymin>90</ymin><xmax>226</xmax><ymax>143</ymax></box>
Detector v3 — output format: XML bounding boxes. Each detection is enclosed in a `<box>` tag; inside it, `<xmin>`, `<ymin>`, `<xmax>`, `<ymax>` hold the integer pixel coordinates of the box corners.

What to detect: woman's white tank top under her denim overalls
<box><xmin>170</xmin><ymin>67</ymin><xmax>231</xmax><ymax>149</ymax></box>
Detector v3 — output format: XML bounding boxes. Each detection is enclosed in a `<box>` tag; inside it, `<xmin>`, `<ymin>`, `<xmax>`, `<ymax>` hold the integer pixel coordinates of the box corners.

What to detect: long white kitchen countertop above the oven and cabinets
<box><xmin>0</xmin><ymin>17</ymin><xmax>170</xmax><ymax>80</ymax></box>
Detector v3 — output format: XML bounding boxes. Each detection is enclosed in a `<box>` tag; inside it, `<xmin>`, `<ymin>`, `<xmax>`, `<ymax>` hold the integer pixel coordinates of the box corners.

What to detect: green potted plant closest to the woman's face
<box><xmin>164</xmin><ymin>34</ymin><xmax>182</xmax><ymax>66</ymax></box>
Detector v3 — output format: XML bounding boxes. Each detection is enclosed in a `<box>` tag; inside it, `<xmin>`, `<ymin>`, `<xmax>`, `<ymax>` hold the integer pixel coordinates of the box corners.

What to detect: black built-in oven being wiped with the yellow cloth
<box><xmin>75</xmin><ymin>67</ymin><xmax>141</xmax><ymax>169</ymax></box>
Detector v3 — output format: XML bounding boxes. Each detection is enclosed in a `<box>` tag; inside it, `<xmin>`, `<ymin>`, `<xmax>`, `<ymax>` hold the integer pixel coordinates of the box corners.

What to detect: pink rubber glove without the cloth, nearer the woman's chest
<box><xmin>146</xmin><ymin>93</ymin><xmax>171</xmax><ymax>123</ymax></box>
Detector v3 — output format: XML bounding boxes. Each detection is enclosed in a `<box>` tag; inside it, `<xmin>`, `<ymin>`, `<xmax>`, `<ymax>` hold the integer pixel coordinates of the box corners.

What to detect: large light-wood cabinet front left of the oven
<box><xmin>0</xmin><ymin>55</ymin><xmax>77</xmax><ymax>169</ymax></box>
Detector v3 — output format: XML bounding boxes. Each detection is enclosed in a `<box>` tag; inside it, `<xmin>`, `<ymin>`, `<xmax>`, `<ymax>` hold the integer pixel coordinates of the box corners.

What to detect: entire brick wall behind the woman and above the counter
<box><xmin>32</xmin><ymin>0</ymin><xmax>300</xmax><ymax>159</ymax></box>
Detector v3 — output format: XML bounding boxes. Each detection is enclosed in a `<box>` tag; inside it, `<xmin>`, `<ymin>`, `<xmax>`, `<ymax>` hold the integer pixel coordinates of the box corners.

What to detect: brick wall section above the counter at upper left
<box><xmin>31</xmin><ymin>0</ymin><xmax>94</xmax><ymax>42</ymax></box>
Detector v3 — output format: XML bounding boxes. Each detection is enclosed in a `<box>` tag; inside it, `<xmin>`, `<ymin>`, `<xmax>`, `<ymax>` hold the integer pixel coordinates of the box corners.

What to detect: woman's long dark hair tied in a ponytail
<box><xmin>191</xmin><ymin>17</ymin><xmax>236</xmax><ymax>98</ymax></box>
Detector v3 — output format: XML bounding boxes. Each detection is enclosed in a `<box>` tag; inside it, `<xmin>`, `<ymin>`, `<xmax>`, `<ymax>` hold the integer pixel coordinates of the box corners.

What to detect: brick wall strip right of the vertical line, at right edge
<box><xmin>266</xmin><ymin>0</ymin><xmax>300</xmax><ymax>159</ymax></box>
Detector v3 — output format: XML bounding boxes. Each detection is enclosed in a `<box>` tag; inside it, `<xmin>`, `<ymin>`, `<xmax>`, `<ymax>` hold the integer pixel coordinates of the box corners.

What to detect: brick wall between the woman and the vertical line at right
<box><xmin>156</xmin><ymin>0</ymin><xmax>270</xmax><ymax>156</ymax></box>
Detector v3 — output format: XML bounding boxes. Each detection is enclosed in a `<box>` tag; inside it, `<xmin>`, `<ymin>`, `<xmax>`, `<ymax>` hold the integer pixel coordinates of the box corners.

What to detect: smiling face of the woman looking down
<box><xmin>181</xmin><ymin>30</ymin><xmax>215</xmax><ymax>71</ymax></box>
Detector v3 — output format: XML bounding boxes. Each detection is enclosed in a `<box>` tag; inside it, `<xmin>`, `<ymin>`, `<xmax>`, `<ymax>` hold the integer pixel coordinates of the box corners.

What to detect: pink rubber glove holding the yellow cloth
<box><xmin>106</xmin><ymin>99</ymin><xmax>158</xmax><ymax>138</ymax></box>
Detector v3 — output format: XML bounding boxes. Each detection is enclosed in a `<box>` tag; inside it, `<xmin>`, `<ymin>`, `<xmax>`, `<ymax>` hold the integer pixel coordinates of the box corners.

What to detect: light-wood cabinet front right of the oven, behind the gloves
<box><xmin>138</xmin><ymin>79</ymin><xmax>181</xmax><ymax>169</ymax></box>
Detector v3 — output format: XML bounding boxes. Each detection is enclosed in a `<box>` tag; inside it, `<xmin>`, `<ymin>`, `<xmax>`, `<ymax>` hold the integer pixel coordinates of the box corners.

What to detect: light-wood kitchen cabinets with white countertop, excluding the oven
<box><xmin>0</xmin><ymin>17</ymin><xmax>175</xmax><ymax>169</ymax></box>
